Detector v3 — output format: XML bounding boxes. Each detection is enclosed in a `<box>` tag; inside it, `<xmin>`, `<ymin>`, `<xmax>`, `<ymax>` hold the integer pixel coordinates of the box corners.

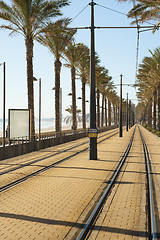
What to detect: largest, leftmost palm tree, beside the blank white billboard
<box><xmin>0</xmin><ymin>0</ymin><xmax>69</xmax><ymax>135</ymax></box>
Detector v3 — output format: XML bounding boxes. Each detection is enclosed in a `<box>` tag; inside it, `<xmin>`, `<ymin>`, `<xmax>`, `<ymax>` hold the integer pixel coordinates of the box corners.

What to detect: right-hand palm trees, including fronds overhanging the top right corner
<box><xmin>115</xmin><ymin>0</ymin><xmax>160</xmax><ymax>127</ymax></box>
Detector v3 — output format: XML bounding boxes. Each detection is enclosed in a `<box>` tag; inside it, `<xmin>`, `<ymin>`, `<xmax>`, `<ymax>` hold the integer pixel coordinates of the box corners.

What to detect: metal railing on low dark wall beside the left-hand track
<box><xmin>0</xmin><ymin>126</ymin><xmax>115</xmax><ymax>160</ymax></box>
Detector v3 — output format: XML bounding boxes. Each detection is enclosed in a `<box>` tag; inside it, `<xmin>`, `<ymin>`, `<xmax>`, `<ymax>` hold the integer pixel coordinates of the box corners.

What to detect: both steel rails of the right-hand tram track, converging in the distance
<box><xmin>73</xmin><ymin>127</ymin><xmax>160</xmax><ymax>240</ymax></box>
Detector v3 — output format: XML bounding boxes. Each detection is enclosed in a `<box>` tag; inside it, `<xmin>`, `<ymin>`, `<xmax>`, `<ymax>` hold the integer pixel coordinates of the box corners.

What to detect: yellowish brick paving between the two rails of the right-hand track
<box><xmin>89</xmin><ymin>126</ymin><xmax>147</xmax><ymax>240</ymax></box>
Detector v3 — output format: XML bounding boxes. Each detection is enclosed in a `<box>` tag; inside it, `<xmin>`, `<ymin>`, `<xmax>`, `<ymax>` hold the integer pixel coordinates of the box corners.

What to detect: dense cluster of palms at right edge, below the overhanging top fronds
<box><xmin>137</xmin><ymin>48</ymin><xmax>160</xmax><ymax>131</ymax></box>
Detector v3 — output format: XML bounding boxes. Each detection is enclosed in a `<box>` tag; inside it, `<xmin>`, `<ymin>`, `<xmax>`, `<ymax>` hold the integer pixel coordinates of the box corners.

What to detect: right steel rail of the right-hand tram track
<box><xmin>139</xmin><ymin>128</ymin><xmax>160</xmax><ymax>240</ymax></box>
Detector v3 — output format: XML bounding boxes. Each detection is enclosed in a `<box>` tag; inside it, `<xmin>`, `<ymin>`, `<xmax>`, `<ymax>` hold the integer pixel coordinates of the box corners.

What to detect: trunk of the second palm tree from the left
<box><xmin>54</xmin><ymin>59</ymin><xmax>62</xmax><ymax>135</ymax></box>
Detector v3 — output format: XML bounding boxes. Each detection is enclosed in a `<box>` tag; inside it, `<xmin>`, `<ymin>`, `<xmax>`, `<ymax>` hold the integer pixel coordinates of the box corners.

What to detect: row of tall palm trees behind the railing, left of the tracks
<box><xmin>0</xmin><ymin>0</ymin><xmax>122</xmax><ymax>135</ymax></box>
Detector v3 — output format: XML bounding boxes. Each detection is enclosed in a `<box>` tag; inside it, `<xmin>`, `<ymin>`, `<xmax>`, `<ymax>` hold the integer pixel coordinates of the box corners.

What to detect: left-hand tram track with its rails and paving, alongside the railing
<box><xmin>0</xmin><ymin>127</ymin><xmax>118</xmax><ymax>193</ymax></box>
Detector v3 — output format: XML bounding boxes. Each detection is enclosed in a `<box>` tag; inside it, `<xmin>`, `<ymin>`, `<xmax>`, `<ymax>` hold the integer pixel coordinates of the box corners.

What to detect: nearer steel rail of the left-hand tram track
<box><xmin>0</xmin><ymin>127</ymin><xmax>118</xmax><ymax>193</ymax></box>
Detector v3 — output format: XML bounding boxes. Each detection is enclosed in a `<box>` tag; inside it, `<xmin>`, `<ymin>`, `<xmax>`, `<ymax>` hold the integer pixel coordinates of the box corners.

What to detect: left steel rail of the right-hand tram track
<box><xmin>78</xmin><ymin>127</ymin><xmax>136</xmax><ymax>240</ymax></box>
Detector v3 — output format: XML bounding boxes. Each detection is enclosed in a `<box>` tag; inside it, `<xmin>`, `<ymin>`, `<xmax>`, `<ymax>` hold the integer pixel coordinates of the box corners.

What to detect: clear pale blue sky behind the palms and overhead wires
<box><xmin>0</xmin><ymin>0</ymin><xmax>160</xmax><ymax>118</ymax></box>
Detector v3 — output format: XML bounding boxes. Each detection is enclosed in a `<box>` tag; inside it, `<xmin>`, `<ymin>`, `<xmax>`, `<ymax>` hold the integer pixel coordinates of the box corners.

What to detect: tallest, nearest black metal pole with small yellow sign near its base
<box><xmin>89</xmin><ymin>0</ymin><xmax>97</xmax><ymax>160</ymax></box>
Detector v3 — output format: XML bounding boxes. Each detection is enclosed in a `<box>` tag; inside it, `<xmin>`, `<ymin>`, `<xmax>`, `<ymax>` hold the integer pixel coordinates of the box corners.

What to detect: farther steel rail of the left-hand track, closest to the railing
<box><xmin>0</xmin><ymin>130</ymin><xmax>118</xmax><ymax>176</ymax></box>
